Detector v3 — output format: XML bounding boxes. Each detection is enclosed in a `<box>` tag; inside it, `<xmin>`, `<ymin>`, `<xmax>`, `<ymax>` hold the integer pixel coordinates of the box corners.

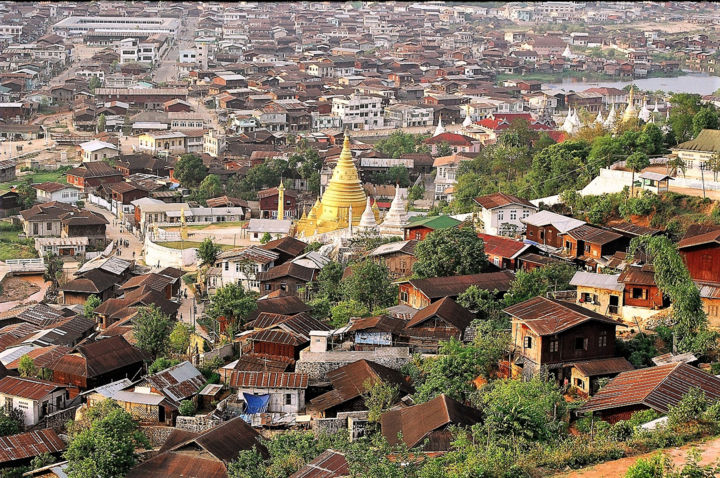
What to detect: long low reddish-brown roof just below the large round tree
<box><xmin>409</xmin><ymin>271</ymin><xmax>515</xmax><ymax>300</ymax></box>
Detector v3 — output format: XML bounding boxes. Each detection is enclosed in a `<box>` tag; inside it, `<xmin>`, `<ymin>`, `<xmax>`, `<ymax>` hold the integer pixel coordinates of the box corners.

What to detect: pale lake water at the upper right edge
<box><xmin>543</xmin><ymin>73</ymin><xmax>720</xmax><ymax>95</ymax></box>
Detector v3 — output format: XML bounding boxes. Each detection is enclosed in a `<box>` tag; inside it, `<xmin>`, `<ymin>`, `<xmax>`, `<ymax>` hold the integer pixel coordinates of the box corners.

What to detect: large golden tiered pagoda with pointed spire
<box><xmin>295</xmin><ymin>135</ymin><xmax>374</xmax><ymax>236</ymax></box>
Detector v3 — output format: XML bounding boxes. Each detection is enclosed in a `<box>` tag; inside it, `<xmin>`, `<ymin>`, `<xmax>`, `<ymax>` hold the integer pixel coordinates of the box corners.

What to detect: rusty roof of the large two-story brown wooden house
<box><xmin>503</xmin><ymin>296</ymin><xmax>624</xmax><ymax>336</ymax></box>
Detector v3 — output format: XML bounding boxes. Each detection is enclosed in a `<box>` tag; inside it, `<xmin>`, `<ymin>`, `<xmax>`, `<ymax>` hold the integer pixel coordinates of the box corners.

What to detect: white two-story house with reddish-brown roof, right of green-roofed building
<box><xmin>475</xmin><ymin>193</ymin><xmax>538</xmax><ymax>236</ymax></box>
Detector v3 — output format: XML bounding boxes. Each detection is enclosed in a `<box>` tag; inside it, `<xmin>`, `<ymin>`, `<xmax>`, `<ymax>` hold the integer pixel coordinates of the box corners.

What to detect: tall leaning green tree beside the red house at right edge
<box><xmin>629</xmin><ymin>236</ymin><xmax>714</xmax><ymax>353</ymax></box>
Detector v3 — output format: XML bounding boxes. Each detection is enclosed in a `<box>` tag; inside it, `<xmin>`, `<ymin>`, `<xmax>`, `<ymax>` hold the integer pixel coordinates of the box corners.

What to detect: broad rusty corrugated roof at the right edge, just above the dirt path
<box><xmin>580</xmin><ymin>363</ymin><xmax>720</xmax><ymax>413</ymax></box>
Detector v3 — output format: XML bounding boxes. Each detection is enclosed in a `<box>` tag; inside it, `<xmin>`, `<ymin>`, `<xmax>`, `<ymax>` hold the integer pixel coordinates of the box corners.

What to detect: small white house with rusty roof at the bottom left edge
<box><xmin>0</xmin><ymin>376</ymin><xmax>68</xmax><ymax>426</ymax></box>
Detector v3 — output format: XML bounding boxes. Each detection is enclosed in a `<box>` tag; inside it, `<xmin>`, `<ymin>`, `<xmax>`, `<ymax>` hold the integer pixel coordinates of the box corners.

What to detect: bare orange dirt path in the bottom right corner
<box><xmin>553</xmin><ymin>438</ymin><xmax>720</xmax><ymax>478</ymax></box>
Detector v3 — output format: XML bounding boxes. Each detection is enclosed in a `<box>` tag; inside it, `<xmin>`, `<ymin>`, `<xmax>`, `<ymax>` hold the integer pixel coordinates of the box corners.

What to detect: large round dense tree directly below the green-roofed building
<box><xmin>413</xmin><ymin>224</ymin><xmax>488</xmax><ymax>279</ymax></box>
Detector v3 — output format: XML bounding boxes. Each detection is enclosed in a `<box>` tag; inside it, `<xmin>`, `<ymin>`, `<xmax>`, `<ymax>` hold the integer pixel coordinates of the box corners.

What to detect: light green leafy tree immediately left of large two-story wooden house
<box><xmin>414</xmin><ymin>323</ymin><xmax>510</xmax><ymax>402</ymax></box>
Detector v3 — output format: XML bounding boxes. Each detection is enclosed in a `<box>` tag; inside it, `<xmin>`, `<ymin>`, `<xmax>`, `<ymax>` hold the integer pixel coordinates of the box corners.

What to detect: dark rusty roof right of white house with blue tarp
<box><xmin>310</xmin><ymin>360</ymin><xmax>413</xmax><ymax>411</ymax></box>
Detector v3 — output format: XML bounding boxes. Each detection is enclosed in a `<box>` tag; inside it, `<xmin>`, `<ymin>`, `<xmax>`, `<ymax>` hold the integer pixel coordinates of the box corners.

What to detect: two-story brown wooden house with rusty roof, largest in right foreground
<box><xmin>504</xmin><ymin>296</ymin><xmax>623</xmax><ymax>383</ymax></box>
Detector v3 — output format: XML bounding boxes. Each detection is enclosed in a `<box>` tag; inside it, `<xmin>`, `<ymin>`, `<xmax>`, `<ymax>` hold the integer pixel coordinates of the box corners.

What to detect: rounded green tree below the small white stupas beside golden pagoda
<box><xmin>341</xmin><ymin>259</ymin><xmax>397</xmax><ymax>310</ymax></box>
